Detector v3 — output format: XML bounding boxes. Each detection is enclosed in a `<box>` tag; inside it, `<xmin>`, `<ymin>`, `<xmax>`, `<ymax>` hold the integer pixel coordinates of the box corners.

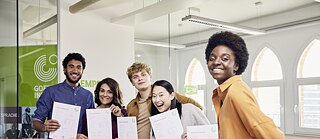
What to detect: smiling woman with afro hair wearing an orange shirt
<box><xmin>205</xmin><ymin>32</ymin><xmax>284</xmax><ymax>139</ymax></box>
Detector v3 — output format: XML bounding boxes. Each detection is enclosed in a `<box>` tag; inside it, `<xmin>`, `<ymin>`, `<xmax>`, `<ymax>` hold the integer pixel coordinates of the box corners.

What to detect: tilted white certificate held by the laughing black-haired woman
<box><xmin>150</xmin><ymin>109</ymin><xmax>183</xmax><ymax>139</ymax></box>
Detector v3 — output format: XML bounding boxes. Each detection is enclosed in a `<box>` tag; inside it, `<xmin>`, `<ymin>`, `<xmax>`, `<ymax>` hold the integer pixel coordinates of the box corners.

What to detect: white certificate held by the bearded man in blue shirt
<box><xmin>49</xmin><ymin>102</ymin><xmax>81</xmax><ymax>139</ymax></box>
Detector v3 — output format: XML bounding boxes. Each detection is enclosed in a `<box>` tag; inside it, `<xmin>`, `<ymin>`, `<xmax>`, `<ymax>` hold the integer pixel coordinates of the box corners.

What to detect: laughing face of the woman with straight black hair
<box><xmin>152</xmin><ymin>86</ymin><xmax>174</xmax><ymax>112</ymax></box>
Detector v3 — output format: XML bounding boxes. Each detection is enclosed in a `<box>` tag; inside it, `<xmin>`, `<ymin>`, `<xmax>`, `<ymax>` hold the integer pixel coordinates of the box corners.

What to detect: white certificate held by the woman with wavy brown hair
<box><xmin>86</xmin><ymin>108</ymin><xmax>112</xmax><ymax>139</ymax></box>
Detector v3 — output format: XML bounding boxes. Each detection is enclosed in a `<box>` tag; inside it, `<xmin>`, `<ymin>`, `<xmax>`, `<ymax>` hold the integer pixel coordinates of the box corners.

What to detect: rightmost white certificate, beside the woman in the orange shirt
<box><xmin>187</xmin><ymin>124</ymin><xmax>218</xmax><ymax>139</ymax></box>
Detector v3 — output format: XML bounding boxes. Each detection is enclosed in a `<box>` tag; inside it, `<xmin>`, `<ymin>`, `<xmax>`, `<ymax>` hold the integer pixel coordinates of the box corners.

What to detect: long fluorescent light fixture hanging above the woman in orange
<box><xmin>182</xmin><ymin>15</ymin><xmax>266</xmax><ymax>35</ymax></box>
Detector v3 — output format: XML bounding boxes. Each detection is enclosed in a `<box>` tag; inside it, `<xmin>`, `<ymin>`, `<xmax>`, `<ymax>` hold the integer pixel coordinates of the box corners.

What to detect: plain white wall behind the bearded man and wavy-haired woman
<box><xmin>58</xmin><ymin>1</ymin><xmax>136</xmax><ymax>105</ymax></box>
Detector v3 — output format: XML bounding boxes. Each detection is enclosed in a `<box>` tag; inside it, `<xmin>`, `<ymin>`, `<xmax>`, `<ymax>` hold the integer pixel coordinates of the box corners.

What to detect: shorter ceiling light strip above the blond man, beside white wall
<box><xmin>135</xmin><ymin>39</ymin><xmax>186</xmax><ymax>49</ymax></box>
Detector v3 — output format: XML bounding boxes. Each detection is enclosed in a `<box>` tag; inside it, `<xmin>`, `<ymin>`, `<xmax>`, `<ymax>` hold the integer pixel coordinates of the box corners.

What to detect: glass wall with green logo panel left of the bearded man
<box><xmin>0</xmin><ymin>0</ymin><xmax>57</xmax><ymax>138</ymax></box>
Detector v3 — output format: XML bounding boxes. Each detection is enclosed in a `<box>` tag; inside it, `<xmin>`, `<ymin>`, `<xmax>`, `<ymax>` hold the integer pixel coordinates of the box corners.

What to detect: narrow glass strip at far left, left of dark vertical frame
<box><xmin>0</xmin><ymin>0</ymin><xmax>18</xmax><ymax>138</ymax></box>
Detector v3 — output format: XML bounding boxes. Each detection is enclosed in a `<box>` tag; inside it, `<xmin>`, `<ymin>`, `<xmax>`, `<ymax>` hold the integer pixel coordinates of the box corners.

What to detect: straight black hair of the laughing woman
<box><xmin>151</xmin><ymin>80</ymin><xmax>181</xmax><ymax>118</ymax></box>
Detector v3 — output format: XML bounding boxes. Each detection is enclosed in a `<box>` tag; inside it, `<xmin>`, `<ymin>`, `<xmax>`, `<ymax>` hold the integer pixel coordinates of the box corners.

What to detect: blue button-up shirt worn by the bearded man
<box><xmin>33</xmin><ymin>81</ymin><xmax>94</xmax><ymax>133</ymax></box>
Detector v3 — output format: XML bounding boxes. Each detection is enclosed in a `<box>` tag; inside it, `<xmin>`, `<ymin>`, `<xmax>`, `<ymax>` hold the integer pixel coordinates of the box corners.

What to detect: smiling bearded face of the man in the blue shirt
<box><xmin>63</xmin><ymin>59</ymin><xmax>83</xmax><ymax>84</ymax></box>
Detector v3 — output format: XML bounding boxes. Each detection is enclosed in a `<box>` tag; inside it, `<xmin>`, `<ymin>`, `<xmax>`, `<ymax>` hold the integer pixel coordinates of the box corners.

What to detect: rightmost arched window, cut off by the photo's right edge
<box><xmin>297</xmin><ymin>39</ymin><xmax>320</xmax><ymax>129</ymax></box>
